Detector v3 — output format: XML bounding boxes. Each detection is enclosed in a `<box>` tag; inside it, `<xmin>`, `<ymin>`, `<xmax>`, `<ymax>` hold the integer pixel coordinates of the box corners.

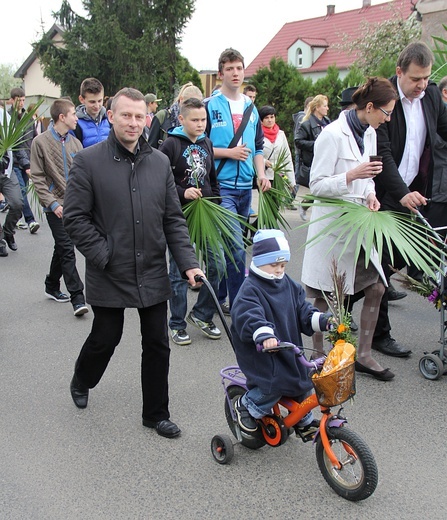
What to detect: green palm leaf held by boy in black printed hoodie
<box><xmin>183</xmin><ymin>197</ymin><xmax>255</xmax><ymax>271</ymax></box>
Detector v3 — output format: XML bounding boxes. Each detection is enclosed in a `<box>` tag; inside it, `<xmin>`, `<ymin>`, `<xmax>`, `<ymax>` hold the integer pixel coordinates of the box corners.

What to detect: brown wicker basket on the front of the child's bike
<box><xmin>312</xmin><ymin>362</ymin><xmax>355</xmax><ymax>406</ymax></box>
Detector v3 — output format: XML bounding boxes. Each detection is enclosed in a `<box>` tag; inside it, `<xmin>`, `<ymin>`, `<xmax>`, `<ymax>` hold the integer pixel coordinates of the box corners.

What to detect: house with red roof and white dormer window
<box><xmin>245</xmin><ymin>0</ymin><xmax>416</xmax><ymax>81</ymax></box>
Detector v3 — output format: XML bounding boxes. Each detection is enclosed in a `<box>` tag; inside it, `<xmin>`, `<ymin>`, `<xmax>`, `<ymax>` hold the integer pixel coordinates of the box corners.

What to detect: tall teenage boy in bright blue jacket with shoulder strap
<box><xmin>205</xmin><ymin>49</ymin><xmax>271</xmax><ymax>314</ymax></box>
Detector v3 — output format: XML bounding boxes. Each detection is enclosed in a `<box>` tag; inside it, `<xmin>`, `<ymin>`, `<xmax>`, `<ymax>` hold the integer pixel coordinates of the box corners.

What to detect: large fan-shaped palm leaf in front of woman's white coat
<box><xmin>299</xmin><ymin>195</ymin><xmax>446</xmax><ymax>276</ymax></box>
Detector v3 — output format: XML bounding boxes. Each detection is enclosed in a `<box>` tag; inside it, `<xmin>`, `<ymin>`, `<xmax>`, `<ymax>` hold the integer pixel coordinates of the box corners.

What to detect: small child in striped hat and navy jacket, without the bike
<box><xmin>231</xmin><ymin>229</ymin><xmax>331</xmax><ymax>436</ymax></box>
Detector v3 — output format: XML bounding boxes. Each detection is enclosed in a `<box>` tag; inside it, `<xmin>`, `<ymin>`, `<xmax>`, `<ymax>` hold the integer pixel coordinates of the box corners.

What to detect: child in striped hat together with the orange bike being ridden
<box><xmin>212</xmin><ymin>230</ymin><xmax>378</xmax><ymax>501</ymax></box>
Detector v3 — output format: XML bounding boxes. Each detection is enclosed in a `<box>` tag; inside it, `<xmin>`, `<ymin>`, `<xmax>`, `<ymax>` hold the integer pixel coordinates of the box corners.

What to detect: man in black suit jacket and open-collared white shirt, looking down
<box><xmin>372</xmin><ymin>42</ymin><xmax>447</xmax><ymax>357</ymax></box>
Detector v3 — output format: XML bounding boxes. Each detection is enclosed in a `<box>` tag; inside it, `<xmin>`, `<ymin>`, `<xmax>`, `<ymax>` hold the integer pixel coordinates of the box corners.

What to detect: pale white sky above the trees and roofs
<box><xmin>0</xmin><ymin>0</ymin><xmax>386</xmax><ymax>70</ymax></box>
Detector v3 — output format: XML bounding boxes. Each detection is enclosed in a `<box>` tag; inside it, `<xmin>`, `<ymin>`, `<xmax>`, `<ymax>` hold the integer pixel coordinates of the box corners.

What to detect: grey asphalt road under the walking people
<box><xmin>0</xmin><ymin>197</ymin><xmax>447</xmax><ymax>520</ymax></box>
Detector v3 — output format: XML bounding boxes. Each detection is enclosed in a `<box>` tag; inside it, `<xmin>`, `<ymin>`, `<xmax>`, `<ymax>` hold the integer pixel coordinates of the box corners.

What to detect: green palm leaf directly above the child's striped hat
<box><xmin>258</xmin><ymin>145</ymin><xmax>291</xmax><ymax>229</ymax></box>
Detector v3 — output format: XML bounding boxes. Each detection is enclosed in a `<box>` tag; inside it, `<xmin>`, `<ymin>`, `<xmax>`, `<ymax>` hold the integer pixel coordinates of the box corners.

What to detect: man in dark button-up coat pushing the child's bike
<box><xmin>64</xmin><ymin>88</ymin><xmax>203</xmax><ymax>437</ymax></box>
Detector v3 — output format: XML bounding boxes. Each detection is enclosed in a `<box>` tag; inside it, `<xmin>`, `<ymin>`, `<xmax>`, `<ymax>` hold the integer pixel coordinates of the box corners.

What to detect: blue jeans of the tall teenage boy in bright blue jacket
<box><xmin>219</xmin><ymin>188</ymin><xmax>251</xmax><ymax>308</ymax></box>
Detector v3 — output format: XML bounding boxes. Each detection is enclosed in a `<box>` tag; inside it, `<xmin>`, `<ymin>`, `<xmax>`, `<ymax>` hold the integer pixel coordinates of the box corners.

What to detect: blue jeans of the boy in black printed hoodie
<box><xmin>169</xmin><ymin>245</ymin><xmax>224</xmax><ymax>330</ymax></box>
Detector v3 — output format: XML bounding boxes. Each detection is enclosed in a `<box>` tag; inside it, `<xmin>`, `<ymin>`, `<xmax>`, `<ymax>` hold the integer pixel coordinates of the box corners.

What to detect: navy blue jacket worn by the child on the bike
<box><xmin>231</xmin><ymin>269</ymin><xmax>321</xmax><ymax>397</ymax></box>
